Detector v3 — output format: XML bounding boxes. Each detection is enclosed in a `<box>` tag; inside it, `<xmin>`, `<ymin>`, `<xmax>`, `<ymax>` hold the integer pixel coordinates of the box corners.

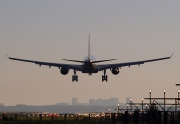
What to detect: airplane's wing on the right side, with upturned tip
<box><xmin>98</xmin><ymin>54</ymin><xmax>173</xmax><ymax>71</ymax></box>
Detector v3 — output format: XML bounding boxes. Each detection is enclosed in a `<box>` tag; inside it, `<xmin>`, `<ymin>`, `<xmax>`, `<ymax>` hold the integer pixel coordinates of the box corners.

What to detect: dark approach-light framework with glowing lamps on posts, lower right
<box><xmin>112</xmin><ymin>89</ymin><xmax>180</xmax><ymax>124</ymax></box>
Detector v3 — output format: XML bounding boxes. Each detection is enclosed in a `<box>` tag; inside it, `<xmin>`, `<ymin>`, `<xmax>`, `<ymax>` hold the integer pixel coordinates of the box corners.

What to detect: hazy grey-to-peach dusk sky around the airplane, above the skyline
<box><xmin>0</xmin><ymin>0</ymin><xmax>180</xmax><ymax>105</ymax></box>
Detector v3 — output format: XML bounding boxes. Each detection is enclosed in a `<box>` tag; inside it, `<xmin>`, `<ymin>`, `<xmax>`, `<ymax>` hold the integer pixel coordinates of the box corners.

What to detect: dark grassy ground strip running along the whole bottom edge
<box><xmin>0</xmin><ymin>112</ymin><xmax>180</xmax><ymax>124</ymax></box>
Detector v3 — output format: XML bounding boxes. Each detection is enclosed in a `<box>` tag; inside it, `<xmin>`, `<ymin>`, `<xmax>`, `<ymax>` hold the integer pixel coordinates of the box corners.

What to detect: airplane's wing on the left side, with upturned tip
<box><xmin>6</xmin><ymin>55</ymin><xmax>81</xmax><ymax>71</ymax></box>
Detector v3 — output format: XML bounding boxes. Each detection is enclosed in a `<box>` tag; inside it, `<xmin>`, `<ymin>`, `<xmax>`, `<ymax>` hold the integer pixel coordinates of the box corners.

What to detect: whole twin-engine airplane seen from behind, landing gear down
<box><xmin>6</xmin><ymin>34</ymin><xmax>173</xmax><ymax>82</ymax></box>
